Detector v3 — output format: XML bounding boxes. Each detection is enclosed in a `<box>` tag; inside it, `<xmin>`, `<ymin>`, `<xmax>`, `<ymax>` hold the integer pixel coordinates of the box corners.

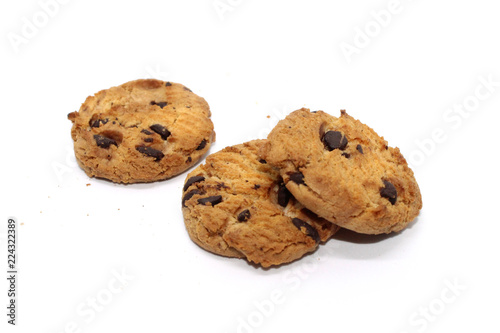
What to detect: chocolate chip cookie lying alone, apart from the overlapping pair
<box><xmin>68</xmin><ymin>79</ymin><xmax>215</xmax><ymax>183</ymax></box>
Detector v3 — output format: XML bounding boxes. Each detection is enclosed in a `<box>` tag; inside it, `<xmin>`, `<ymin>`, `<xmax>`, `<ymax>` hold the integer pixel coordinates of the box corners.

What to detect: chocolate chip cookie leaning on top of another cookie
<box><xmin>259</xmin><ymin>108</ymin><xmax>422</xmax><ymax>234</ymax></box>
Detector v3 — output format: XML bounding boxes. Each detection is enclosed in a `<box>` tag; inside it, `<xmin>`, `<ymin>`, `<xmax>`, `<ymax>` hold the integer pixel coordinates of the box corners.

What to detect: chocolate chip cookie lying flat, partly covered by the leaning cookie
<box><xmin>182</xmin><ymin>140</ymin><xmax>339</xmax><ymax>267</ymax></box>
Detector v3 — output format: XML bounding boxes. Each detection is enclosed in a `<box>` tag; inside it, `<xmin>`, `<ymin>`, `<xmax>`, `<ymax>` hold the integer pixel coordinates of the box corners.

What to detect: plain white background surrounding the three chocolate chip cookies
<box><xmin>0</xmin><ymin>0</ymin><xmax>500</xmax><ymax>333</ymax></box>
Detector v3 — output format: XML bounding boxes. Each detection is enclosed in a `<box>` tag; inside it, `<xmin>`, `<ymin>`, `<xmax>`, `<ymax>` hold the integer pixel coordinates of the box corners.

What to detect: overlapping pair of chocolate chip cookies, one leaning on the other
<box><xmin>182</xmin><ymin>109</ymin><xmax>422</xmax><ymax>267</ymax></box>
